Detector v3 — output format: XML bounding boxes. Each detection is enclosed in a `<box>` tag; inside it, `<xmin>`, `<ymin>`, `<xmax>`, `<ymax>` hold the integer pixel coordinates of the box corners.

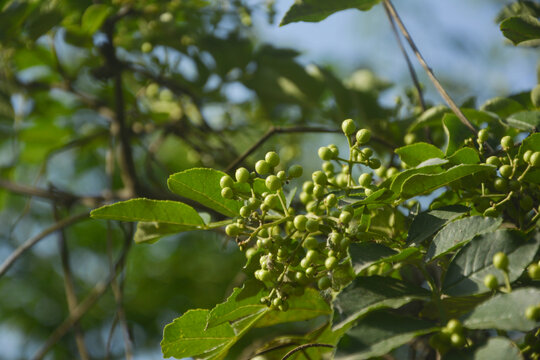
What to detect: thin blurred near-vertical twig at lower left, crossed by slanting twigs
<box><xmin>53</xmin><ymin>204</ymin><xmax>90</xmax><ymax>360</ymax></box>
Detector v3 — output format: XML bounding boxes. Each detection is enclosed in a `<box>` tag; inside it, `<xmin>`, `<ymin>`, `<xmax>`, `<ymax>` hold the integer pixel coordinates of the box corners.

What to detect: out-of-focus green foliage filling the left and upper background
<box><xmin>0</xmin><ymin>0</ymin><xmax>535</xmax><ymax>359</ymax></box>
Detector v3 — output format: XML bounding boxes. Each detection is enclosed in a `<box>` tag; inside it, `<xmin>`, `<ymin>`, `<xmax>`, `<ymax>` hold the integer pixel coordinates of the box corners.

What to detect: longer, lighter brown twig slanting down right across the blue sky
<box><xmin>384</xmin><ymin>0</ymin><xmax>477</xmax><ymax>134</ymax></box>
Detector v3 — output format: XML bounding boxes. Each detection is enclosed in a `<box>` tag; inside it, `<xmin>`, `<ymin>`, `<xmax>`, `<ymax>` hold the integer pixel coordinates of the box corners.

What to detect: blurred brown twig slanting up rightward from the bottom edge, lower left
<box><xmin>32</xmin><ymin>235</ymin><xmax>131</xmax><ymax>360</ymax></box>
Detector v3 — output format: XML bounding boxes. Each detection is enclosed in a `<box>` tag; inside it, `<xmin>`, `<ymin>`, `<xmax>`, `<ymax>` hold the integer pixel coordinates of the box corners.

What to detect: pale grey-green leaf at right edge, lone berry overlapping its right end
<box><xmin>463</xmin><ymin>288</ymin><xmax>540</xmax><ymax>331</ymax></box>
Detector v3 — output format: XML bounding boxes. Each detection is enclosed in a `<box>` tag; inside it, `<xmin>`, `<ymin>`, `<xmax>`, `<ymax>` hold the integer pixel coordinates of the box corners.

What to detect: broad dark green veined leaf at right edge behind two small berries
<box><xmin>442</xmin><ymin>230</ymin><xmax>540</xmax><ymax>296</ymax></box>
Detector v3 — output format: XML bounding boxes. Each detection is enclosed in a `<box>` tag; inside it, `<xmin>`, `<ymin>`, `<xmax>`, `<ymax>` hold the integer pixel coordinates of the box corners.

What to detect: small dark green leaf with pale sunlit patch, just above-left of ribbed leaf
<box><xmin>407</xmin><ymin>205</ymin><xmax>469</xmax><ymax>245</ymax></box>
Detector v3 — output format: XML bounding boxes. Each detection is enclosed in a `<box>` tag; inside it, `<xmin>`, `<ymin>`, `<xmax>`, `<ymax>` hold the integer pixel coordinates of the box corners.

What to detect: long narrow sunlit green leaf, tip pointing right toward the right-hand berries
<box><xmin>401</xmin><ymin>164</ymin><xmax>495</xmax><ymax>197</ymax></box>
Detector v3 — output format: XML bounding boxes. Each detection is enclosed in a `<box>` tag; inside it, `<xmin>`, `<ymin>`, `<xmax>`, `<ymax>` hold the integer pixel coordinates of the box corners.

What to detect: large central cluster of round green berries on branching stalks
<box><xmin>220</xmin><ymin>119</ymin><xmax>381</xmax><ymax>311</ymax></box>
